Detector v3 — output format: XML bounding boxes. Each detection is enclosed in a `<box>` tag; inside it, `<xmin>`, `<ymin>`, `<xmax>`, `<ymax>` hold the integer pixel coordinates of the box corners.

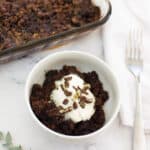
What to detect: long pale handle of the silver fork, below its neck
<box><xmin>133</xmin><ymin>76</ymin><xmax>146</xmax><ymax>150</ymax></box>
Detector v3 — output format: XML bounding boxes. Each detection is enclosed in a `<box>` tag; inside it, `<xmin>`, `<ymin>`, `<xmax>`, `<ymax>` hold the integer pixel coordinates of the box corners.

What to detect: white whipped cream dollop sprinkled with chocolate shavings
<box><xmin>50</xmin><ymin>74</ymin><xmax>95</xmax><ymax>123</ymax></box>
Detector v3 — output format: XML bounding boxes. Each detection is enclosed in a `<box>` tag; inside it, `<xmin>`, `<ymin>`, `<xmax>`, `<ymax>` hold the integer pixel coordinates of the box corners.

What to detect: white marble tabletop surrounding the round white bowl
<box><xmin>0</xmin><ymin>31</ymin><xmax>150</xmax><ymax>150</ymax></box>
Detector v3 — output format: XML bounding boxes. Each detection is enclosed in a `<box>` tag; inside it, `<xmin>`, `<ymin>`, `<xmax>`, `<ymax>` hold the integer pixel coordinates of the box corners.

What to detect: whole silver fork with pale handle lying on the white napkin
<box><xmin>126</xmin><ymin>26</ymin><xmax>146</xmax><ymax>150</ymax></box>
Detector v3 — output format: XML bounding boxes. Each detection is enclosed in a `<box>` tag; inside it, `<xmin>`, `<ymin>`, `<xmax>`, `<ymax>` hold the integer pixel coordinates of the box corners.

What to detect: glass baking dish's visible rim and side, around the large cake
<box><xmin>0</xmin><ymin>0</ymin><xmax>112</xmax><ymax>64</ymax></box>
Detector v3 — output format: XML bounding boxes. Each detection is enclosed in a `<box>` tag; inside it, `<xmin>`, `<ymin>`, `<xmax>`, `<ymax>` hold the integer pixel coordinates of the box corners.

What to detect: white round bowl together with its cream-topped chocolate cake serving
<box><xmin>25</xmin><ymin>51</ymin><xmax>120</xmax><ymax>139</ymax></box>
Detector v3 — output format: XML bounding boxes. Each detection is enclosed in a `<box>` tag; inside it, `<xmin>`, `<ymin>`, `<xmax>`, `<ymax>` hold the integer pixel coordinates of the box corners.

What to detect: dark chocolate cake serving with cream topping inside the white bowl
<box><xmin>30</xmin><ymin>66</ymin><xmax>108</xmax><ymax>136</ymax></box>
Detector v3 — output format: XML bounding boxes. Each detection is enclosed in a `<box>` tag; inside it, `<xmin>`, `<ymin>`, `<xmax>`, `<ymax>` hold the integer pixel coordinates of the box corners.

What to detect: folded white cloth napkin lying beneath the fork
<box><xmin>103</xmin><ymin>0</ymin><xmax>150</xmax><ymax>133</ymax></box>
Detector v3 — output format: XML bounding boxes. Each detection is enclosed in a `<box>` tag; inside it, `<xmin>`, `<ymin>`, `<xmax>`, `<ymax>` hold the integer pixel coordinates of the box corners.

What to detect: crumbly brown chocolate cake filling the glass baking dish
<box><xmin>0</xmin><ymin>0</ymin><xmax>100</xmax><ymax>50</ymax></box>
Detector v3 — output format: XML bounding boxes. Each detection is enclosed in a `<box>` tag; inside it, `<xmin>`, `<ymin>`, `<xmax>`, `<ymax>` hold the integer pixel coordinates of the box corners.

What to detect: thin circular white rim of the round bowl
<box><xmin>25</xmin><ymin>50</ymin><xmax>120</xmax><ymax>140</ymax></box>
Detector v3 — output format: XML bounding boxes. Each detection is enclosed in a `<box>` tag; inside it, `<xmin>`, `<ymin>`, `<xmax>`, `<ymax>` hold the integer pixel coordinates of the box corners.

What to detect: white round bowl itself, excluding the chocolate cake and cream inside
<box><xmin>25</xmin><ymin>51</ymin><xmax>120</xmax><ymax>140</ymax></box>
